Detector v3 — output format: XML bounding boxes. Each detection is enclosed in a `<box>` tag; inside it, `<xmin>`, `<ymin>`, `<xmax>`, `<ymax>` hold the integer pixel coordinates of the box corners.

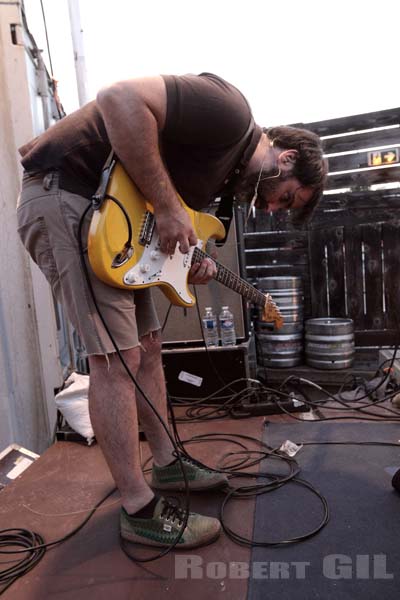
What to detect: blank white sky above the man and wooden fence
<box><xmin>25</xmin><ymin>0</ymin><xmax>400</xmax><ymax>125</ymax></box>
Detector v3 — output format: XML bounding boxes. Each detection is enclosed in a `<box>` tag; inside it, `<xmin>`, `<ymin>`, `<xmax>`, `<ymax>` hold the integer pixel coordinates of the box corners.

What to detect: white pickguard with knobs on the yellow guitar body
<box><xmin>124</xmin><ymin>230</ymin><xmax>203</xmax><ymax>304</ymax></box>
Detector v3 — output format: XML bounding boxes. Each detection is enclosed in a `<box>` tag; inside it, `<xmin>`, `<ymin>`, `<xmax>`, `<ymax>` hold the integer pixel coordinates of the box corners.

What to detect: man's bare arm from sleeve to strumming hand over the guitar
<box><xmin>97</xmin><ymin>77</ymin><xmax>197</xmax><ymax>253</ymax></box>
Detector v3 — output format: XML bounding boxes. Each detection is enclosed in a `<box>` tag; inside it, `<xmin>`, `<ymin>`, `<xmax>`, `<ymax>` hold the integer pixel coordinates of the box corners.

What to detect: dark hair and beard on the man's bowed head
<box><xmin>263</xmin><ymin>127</ymin><xmax>328</xmax><ymax>224</ymax></box>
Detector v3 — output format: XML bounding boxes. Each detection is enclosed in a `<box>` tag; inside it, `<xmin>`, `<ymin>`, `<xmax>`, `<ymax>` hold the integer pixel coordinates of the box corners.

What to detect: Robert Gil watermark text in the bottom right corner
<box><xmin>175</xmin><ymin>554</ymin><xmax>394</xmax><ymax>579</ymax></box>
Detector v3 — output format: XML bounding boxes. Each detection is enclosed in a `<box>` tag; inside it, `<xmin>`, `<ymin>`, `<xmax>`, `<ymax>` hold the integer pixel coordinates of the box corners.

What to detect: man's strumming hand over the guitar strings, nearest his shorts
<box><xmin>155</xmin><ymin>205</ymin><xmax>197</xmax><ymax>254</ymax></box>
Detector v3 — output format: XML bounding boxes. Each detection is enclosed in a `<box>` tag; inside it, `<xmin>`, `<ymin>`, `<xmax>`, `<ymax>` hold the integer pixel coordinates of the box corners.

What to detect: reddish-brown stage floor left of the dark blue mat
<box><xmin>0</xmin><ymin>417</ymin><xmax>264</xmax><ymax>600</ymax></box>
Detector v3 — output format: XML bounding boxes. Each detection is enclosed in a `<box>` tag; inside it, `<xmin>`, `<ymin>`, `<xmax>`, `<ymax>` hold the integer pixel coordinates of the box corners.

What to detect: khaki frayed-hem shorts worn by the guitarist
<box><xmin>17</xmin><ymin>173</ymin><xmax>160</xmax><ymax>355</ymax></box>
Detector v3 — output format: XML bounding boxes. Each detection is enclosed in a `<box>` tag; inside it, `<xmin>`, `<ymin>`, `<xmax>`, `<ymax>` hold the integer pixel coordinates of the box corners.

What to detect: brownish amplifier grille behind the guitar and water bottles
<box><xmin>153</xmin><ymin>209</ymin><xmax>250</xmax><ymax>347</ymax></box>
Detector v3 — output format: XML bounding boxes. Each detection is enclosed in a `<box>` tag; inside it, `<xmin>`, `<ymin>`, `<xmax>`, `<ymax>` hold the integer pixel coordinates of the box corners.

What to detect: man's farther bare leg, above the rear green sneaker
<box><xmin>136</xmin><ymin>331</ymin><xmax>176</xmax><ymax>467</ymax></box>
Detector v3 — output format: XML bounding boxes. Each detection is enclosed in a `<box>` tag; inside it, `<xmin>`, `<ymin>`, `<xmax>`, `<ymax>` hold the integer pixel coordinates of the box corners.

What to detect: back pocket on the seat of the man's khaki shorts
<box><xmin>18</xmin><ymin>217</ymin><xmax>57</xmax><ymax>285</ymax></box>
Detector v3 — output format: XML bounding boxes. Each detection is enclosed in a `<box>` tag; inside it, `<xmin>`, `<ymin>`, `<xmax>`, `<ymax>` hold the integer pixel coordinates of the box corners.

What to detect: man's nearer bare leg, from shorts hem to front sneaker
<box><xmin>89</xmin><ymin>347</ymin><xmax>154</xmax><ymax>514</ymax></box>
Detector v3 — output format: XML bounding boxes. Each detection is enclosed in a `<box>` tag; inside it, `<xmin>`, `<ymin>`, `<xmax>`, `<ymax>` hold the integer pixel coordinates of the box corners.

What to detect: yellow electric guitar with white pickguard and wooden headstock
<box><xmin>88</xmin><ymin>162</ymin><xmax>283</xmax><ymax>328</ymax></box>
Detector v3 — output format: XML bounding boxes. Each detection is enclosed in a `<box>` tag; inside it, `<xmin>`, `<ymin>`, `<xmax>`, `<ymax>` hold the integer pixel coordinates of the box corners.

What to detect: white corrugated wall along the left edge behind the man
<box><xmin>0</xmin><ymin>5</ymin><xmax>62</xmax><ymax>453</ymax></box>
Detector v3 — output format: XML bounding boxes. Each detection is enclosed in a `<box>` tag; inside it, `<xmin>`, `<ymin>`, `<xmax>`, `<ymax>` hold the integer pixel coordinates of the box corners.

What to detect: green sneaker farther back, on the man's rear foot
<box><xmin>150</xmin><ymin>456</ymin><xmax>228</xmax><ymax>491</ymax></box>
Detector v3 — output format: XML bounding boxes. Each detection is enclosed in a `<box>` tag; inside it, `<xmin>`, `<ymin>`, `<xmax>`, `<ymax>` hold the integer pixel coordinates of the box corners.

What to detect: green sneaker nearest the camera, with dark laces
<box><xmin>120</xmin><ymin>497</ymin><xmax>221</xmax><ymax>549</ymax></box>
